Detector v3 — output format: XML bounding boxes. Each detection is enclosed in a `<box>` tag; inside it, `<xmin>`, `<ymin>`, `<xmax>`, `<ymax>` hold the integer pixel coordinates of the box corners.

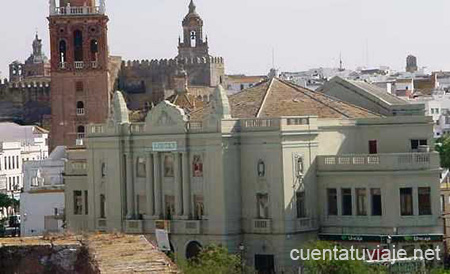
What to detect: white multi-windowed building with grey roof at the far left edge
<box><xmin>0</xmin><ymin>123</ymin><xmax>48</xmax><ymax>218</ymax></box>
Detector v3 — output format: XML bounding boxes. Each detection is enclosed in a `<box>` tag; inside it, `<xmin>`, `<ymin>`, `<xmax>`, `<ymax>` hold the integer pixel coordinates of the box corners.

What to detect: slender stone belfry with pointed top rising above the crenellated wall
<box><xmin>178</xmin><ymin>0</ymin><xmax>209</xmax><ymax>58</ymax></box>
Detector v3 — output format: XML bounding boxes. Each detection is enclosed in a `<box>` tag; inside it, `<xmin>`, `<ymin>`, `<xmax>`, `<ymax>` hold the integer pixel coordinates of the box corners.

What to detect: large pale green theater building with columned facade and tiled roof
<box><xmin>64</xmin><ymin>78</ymin><xmax>442</xmax><ymax>273</ymax></box>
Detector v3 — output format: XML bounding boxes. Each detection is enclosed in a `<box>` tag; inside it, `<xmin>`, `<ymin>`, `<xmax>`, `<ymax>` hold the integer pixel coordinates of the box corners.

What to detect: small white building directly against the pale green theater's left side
<box><xmin>20</xmin><ymin>147</ymin><xmax>66</xmax><ymax>237</ymax></box>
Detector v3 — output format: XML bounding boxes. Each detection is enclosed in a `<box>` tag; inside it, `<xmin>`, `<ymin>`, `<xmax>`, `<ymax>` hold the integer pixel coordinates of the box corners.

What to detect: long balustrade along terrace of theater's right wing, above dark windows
<box><xmin>318</xmin><ymin>152</ymin><xmax>440</xmax><ymax>171</ymax></box>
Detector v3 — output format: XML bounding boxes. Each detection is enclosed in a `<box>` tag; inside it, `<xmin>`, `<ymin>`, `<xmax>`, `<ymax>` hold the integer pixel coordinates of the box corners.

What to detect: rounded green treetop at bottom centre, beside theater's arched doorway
<box><xmin>177</xmin><ymin>245</ymin><xmax>248</xmax><ymax>274</ymax></box>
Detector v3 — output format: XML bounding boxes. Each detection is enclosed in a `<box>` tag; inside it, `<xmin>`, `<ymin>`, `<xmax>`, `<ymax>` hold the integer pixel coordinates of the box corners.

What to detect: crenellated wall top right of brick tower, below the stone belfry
<box><xmin>122</xmin><ymin>56</ymin><xmax>224</xmax><ymax>69</ymax></box>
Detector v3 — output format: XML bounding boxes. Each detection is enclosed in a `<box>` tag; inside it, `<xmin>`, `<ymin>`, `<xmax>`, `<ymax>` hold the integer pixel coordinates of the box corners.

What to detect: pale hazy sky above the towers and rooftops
<box><xmin>0</xmin><ymin>0</ymin><xmax>450</xmax><ymax>77</ymax></box>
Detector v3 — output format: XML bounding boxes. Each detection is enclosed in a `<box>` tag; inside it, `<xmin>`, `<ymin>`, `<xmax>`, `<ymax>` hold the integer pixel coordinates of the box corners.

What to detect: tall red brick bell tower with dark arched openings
<box><xmin>48</xmin><ymin>0</ymin><xmax>111</xmax><ymax>148</ymax></box>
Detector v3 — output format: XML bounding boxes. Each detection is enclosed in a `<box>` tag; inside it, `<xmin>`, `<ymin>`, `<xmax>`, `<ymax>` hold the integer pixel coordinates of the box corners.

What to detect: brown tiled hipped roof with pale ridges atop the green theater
<box><xmin>229</xmin><ymin>78</ymin><xmax>379</xmax><ymax>118</ymax></box>
